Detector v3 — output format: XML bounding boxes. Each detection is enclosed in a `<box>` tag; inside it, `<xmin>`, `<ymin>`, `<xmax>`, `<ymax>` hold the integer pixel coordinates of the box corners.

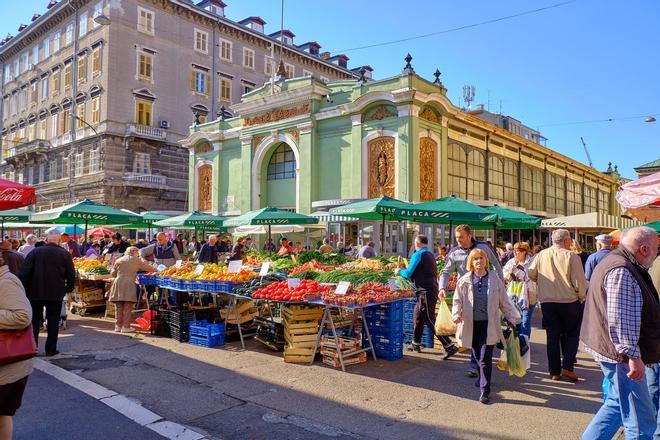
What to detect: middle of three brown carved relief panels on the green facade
<box><xmin>367</xmin><ymin>136</ymin><xmax>395</xmax><ymax>198</ymax></box>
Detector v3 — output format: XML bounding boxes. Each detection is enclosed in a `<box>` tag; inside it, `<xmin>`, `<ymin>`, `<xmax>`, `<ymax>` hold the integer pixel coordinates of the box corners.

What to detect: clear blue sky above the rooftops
<box><xmin>0</xmin><ymin>0</ymin><xmax>660</xmax><ymax>177</ymax></box>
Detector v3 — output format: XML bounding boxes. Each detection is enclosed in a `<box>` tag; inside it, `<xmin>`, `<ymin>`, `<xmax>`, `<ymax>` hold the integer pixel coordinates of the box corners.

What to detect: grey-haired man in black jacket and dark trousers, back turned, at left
<box><xmin>19</xmin><ymin>228</ymin><xmax>76</xmax><ymax>356</ymax></box>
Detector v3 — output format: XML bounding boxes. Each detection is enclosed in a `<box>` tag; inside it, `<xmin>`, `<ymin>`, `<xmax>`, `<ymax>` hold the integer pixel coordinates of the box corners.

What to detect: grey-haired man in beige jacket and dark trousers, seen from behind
<box><xmin>529</xmin><ymin>229</ymin><xmax>588</xmax><ymax>382</ymax></box>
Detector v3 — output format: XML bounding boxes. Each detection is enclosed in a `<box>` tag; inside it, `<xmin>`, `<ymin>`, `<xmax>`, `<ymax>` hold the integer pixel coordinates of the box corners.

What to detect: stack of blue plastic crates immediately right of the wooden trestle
<box><xmin>362</xmin><ymin>301</ymin><xmax>403</xmax><ymax>361</ymax></box>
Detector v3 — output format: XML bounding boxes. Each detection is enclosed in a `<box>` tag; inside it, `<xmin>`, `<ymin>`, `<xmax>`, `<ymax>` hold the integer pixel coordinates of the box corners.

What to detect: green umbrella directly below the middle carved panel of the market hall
<box><xmin>330</xmin><ymin>196</ymin><xmax>415</xmax><ymax>254</ymax></box>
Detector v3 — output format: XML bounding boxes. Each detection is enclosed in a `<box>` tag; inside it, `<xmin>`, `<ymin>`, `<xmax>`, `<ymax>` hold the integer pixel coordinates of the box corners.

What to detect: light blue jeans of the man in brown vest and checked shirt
<box><xmin>582</xmin><ymin>362</ymin><xmax>657</xmax><ymax>440</ymax></box>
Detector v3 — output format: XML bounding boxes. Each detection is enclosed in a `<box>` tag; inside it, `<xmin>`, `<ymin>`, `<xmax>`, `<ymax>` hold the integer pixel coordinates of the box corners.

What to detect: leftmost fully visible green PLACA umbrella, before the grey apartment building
<box><xmin>30</xmin><ymin>199</ymin><xmax>139</xmax><ymax>239</ymax></box>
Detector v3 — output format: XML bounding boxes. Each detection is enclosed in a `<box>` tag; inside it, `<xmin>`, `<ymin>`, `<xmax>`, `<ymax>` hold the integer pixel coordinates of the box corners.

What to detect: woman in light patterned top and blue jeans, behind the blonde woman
<box><xmin>502</xmin><ymin>241</ymin><xmax>537</xmax><ymax>339</ymax></box>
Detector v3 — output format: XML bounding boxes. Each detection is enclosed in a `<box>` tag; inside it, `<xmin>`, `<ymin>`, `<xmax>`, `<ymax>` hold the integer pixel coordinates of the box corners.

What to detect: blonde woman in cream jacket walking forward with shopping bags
<box><xmin>452</xmin><ymin>248</ymin><xmax>520</xmax><ymax>404</ymax></box>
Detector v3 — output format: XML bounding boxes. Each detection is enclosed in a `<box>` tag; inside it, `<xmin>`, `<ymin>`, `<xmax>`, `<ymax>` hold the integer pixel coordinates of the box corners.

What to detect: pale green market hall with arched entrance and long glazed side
<box><xmin>182</xmin><ymin>58</ymin><xmax>618</xmax><ymax>252</ymax></box>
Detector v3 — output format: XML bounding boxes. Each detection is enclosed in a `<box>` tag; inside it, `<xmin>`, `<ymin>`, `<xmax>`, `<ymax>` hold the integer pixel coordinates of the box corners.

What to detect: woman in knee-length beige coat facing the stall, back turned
<box><xmin>110</xmin><ymin>246</ymin><xmax>155</xmax><ymax>333</ymax></box>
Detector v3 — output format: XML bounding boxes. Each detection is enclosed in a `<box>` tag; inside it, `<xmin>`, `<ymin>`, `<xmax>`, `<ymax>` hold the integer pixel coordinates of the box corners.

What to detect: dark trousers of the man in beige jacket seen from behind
<box><xmin>541</xmin><ymin>301</ymin><xmax>582</xmax><ymax>376</ymax></box>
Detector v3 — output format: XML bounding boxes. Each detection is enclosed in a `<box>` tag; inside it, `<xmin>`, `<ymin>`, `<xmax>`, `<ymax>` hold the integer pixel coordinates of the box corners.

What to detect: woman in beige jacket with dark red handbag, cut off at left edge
<box><xmin>0</xmin><ymin>251</ymin><xmax>37</xmax><ymax>440</ymax></box>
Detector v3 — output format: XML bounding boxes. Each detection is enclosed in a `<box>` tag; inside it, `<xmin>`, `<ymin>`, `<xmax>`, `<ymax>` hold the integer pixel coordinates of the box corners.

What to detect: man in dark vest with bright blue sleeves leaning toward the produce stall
<box><xmin>397</xmin><ymin>235</ymin><xmax>458</xmax><ymax>359</ymax></box>
